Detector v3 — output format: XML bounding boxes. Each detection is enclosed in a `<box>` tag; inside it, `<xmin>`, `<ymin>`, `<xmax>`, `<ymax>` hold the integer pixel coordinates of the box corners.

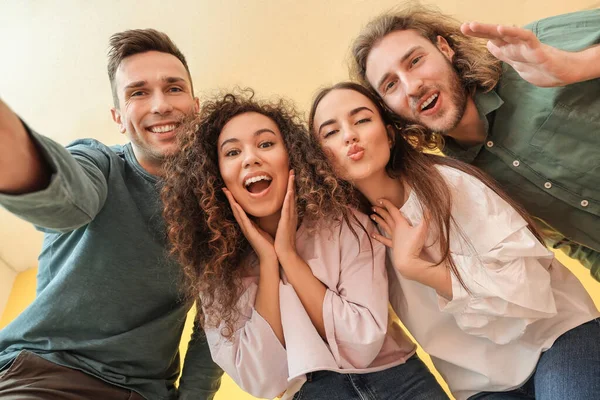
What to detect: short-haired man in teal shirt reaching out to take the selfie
<box><xmin>0</xmin><ymin>29</ymin><xmax>222</xmax><ymax>400</ymax></box>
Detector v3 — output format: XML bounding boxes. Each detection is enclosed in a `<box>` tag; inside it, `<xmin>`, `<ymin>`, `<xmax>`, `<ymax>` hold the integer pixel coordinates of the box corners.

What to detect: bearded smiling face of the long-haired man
<box><xmin>366</xmin><ymin>30</ymin><xmax>467</xmax><ymax>133</ymax></box>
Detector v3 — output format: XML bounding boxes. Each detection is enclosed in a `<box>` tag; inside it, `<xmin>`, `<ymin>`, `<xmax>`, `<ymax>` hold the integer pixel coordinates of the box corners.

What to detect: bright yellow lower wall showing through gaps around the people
<box><xmin>0</xmin><ymin>253</ymin><xmax>600</xmax><ymax>400</ymax></box>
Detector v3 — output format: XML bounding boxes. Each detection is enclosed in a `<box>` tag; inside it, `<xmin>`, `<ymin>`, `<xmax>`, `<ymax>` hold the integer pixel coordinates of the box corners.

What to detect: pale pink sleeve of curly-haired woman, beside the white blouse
<box><xmin>322</xmin><ymin>213</ymin><xmax>388</xmax><ymax>369</ymax></box>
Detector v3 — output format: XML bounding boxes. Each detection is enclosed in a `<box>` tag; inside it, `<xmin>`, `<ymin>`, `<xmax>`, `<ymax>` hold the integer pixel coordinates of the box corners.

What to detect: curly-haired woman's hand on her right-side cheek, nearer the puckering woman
<box><xmin>275</xmin><ymin>170</ymin><xmax>298</xmax><ymax>262</ymax></box>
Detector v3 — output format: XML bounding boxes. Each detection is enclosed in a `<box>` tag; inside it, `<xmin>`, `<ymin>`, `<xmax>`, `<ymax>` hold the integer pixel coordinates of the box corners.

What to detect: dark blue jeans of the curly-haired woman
<box><xmin>294</xmin><ymin>354</ymin><xmax>448</xmax><ymax>400</ymax></box>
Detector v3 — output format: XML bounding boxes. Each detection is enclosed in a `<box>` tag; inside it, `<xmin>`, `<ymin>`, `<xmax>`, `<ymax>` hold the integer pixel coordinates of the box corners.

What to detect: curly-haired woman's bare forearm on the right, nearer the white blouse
<box><xmin>280</xmin><ymin>254</ymin><xmax>327</xmax><ymax>339</ymax></box>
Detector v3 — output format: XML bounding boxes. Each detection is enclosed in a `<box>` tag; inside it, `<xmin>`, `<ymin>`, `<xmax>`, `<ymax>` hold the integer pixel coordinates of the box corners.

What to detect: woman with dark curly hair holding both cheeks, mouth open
<box><xmin>163</xmin><ymin>92</ymin><xmax>447</xmax><ymax>400</ymax></box>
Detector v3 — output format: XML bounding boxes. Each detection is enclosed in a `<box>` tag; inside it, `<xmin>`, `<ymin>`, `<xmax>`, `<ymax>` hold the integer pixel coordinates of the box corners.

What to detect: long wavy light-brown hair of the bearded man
<box><xmin>350</xmin><ymin>2</ymin><xmax>502</xmax><ymax>149</ymax></box>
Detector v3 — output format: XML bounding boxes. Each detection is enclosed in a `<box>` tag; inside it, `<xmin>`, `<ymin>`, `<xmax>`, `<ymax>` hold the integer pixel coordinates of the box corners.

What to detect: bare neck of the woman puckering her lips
<box><xmin>354</xmin><ymin>169</ymin><xmax>408</xmax><ymax>208</ymax></box>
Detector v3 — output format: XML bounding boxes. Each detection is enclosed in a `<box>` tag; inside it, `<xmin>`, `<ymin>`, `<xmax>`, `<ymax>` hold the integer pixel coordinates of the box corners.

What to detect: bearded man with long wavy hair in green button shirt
<box><xmin>352</xmin><ymin>5</ymin><xmax>600</xmax><ymax>281</ymax></box>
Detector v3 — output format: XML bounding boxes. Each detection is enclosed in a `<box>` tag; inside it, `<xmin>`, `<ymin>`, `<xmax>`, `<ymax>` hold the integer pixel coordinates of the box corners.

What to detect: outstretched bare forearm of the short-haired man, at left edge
<box><xmin>0</xmin><ymin>100</ymin><xmax>51</xmax><ymax>194</ymax></box>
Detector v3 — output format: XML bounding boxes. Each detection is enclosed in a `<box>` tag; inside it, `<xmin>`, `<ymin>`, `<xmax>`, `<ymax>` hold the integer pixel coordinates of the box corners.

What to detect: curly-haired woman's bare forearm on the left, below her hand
<box><xmin>254</xmin><ymin>260</ymin><xmax>285</xmax><ymax>347</ymax></box>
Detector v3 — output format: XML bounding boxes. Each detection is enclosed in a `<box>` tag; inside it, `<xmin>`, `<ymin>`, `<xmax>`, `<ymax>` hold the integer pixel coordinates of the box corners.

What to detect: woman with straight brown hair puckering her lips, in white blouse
<box><xmin>309</xmin><ymin>82</ymin><xmax>600</xmax><ymax>400</ymax></box>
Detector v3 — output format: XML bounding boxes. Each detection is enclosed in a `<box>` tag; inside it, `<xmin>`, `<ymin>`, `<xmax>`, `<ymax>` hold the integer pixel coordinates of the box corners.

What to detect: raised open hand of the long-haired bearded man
<box><xmin>460</xmin><ymin>22</ymin><xmax>575</xmax><ymax>87</ymax></box>
